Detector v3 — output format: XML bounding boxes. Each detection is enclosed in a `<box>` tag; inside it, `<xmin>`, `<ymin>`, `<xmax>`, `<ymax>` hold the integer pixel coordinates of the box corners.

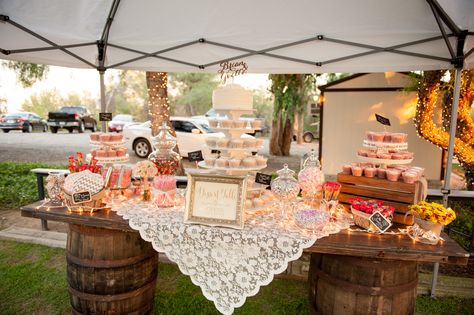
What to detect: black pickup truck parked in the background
<box><xmin>48</xmin><ymin>106</ymin><xmax>97</xmax><ymax>133</ymax></box>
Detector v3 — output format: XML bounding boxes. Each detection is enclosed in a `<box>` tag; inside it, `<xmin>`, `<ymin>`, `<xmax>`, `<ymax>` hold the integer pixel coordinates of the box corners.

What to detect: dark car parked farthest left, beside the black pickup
<box><xmin>0</xmin><ymin>113</ymin><xmax>48</xmax><ymax>132</ymax></box>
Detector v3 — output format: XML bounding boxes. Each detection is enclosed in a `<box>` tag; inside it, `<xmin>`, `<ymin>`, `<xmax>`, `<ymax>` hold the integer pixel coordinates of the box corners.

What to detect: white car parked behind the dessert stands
<box><xmin>123</xmin><ymin>117</ymin><xmax>253</xmax><ymax>158</ymax></box>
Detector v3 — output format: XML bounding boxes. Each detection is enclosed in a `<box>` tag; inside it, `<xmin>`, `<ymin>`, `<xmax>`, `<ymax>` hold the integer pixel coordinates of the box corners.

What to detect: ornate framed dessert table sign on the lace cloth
<box><xmin>184</xmin><ymin>173</ymin><xmax>247</xmax><ymax>229</ymax></box>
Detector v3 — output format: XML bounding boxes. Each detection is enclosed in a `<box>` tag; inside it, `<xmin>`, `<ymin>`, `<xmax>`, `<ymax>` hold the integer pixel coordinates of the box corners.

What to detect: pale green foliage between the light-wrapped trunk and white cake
<box><xmin>170</xmin><ymin>73</ymin><xmax>219</xmax><ymax>116</ymax></box>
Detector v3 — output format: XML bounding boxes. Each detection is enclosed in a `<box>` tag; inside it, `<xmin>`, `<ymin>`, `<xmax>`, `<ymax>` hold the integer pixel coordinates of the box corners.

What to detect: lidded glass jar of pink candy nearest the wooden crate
<box><xmin>298</xmin><ymin>150</ymin><xmax>324</xmax><ymax>208</ymax></box>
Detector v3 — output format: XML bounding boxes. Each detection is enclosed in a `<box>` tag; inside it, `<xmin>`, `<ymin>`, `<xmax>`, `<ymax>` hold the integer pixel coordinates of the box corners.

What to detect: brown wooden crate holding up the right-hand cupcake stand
<box><xmin>337</xmin><ymin>173</ymin><xmax>423</xmax><ymax>225</ymax></box>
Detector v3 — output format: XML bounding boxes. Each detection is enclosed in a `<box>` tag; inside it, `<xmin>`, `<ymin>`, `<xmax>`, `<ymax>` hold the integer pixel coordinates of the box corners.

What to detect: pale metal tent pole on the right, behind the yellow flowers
<box><xmin>431</xmin><ymin>68</ymin><xmax>462</xmax><ymax>298</ymax></box>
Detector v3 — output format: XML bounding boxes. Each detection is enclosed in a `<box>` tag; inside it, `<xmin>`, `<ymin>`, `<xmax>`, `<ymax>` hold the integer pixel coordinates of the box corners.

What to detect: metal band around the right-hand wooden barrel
<box><xmin>316</xmin><ymin>269</ymin><xmax>418</xmax><ymax>296</ymax></box>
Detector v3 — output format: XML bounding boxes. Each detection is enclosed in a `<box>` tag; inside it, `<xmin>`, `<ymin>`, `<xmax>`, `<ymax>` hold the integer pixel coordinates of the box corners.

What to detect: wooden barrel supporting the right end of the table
<box><xmin>309</xmin><ymin>253</ymin><xmax>418</xmax><ymax>315</ymax></box>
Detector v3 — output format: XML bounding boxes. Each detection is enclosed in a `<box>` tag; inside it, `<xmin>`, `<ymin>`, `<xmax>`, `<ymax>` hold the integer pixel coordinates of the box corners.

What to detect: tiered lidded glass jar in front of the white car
<box><xmin>148</xmin><ymin>123</ymin><xmax>181</xmax><ymax>176</ymax></box>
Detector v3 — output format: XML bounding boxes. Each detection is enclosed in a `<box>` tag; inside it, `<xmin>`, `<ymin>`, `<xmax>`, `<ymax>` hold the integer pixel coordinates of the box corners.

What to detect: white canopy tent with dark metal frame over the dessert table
<box><xmin>0</xmin><ymin>0</ymin><xmax>474</xmax><ymax>294</ymax></box>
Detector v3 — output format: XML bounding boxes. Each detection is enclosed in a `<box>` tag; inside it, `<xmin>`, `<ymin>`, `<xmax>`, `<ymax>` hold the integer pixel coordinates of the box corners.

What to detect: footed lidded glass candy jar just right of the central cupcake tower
<box><xmin>271</xmin><ymin>164</ymin><xmax>300</xmax><ymax>219</ymax></box>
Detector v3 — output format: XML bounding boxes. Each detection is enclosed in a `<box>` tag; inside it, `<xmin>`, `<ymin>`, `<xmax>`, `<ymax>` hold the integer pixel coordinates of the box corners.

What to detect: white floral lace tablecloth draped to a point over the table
<box><xmin>112</xmin><ymin>200</ymin><xmax>351</xmax><ymax>314</ymax></box>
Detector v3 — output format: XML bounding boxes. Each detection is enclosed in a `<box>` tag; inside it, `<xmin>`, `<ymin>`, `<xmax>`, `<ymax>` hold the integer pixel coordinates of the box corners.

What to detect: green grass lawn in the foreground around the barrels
<box><xmin>0</xmin><ymin>241</ymin><xmax>474</xmax><ymax>315</ymax></box>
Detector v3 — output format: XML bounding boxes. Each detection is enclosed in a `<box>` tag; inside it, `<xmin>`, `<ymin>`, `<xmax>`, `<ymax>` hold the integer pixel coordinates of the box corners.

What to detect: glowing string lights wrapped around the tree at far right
<box><xmin>415</xmin><ymin>71</ymin><xmax>474</xmax><ymax>166</ymax></box>
